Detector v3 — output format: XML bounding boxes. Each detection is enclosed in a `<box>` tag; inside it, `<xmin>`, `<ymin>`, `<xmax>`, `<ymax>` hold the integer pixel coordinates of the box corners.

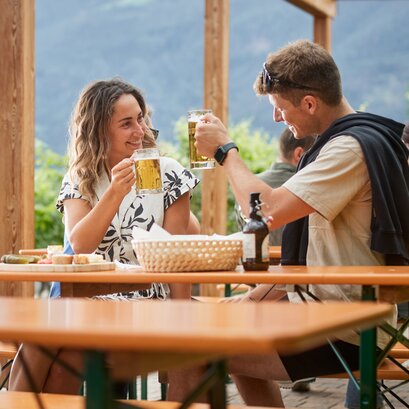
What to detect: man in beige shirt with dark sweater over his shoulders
<box><xmin>195</xmin><ymin>40</ymin><xmax>409</xmax><ymax>406</ymax></box>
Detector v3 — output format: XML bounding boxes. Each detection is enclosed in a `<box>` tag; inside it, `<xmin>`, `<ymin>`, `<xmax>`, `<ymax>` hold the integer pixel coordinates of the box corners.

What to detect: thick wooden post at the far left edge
<box><xmin>0</xmin><ymin>0</ymin><xmax>35</xmax><ymax>296</ymax></box>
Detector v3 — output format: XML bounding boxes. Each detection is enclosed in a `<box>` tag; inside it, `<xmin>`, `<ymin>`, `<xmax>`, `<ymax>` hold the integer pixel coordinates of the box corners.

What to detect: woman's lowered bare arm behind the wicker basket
<box><xmin>163</xmin><ymin>192</ymin><xmax>191</xmax><ymax>299</ymax></box>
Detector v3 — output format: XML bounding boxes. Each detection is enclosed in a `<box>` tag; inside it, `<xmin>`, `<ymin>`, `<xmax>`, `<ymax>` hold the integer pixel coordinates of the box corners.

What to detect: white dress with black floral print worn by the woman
<box><xmin>56</xmin><ymin>157</ymin><xmax>199</xmax><ymax>298</ymax></box>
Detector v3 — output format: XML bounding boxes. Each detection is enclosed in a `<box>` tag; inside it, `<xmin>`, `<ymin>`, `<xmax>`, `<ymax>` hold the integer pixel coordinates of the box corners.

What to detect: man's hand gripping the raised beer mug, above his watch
<box><xmin>195</xmin><ymin>114</ymin><xmax>231</xmax><ymax>158</ymax></box>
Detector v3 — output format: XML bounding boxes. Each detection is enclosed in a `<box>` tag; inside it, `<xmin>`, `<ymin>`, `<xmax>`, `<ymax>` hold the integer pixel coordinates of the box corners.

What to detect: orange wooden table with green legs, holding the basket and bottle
<box><xmin>0</xmin><ymin>266</ymin><xmax>409</xmax><ymax>408</ymax></box>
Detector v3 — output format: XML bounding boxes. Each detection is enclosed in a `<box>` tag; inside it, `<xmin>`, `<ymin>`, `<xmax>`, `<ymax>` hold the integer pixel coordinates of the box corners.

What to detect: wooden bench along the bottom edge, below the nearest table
<box><xmin>0</xmin><ymin>392</ymin><xmax>284</xmax><ymax>409</ymax></box>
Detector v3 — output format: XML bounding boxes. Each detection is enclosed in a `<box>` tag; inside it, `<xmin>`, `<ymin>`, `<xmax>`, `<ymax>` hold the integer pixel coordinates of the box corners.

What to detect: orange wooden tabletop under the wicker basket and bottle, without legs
<box><xmin>0</xmin><ymin>266</ymin><xmax>409</xmax><ymax>293</ymax></box>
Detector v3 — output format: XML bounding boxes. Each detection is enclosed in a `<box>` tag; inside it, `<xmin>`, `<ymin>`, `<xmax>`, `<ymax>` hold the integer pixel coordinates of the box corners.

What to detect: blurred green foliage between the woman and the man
<box><xmin>160</xmin><ymin>118</ymin><xmax>278</xmax><ymax>234</ymax></box>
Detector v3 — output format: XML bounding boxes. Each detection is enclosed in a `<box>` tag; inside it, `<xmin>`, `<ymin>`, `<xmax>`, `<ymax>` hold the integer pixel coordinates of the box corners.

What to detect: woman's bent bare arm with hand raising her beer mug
<box><xmin>64</xmin><ymin>159</ymin><xmax>135</xmax><ymax>253</ymax></box>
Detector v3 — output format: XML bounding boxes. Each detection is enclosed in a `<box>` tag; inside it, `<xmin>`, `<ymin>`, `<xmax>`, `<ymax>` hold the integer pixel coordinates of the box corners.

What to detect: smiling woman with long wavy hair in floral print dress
<box><xmin>9</xmin><ymin>78</ymin><xmax>199</xmax><ymax>398</ymax></box>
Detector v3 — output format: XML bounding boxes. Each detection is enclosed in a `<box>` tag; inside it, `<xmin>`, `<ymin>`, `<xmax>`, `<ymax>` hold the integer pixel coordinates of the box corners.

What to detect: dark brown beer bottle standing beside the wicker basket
<box><xmin>243</xmin><ymin>193</ymin><xmax>270</xmax><ymax>271</ymax></box>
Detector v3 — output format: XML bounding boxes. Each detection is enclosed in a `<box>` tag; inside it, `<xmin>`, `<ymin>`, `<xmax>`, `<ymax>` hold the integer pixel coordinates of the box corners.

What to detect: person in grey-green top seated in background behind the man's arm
<box><xmin>235</xmin><ymin>128</ymin><xmax>315</xmax><ymax>246</ymax></box>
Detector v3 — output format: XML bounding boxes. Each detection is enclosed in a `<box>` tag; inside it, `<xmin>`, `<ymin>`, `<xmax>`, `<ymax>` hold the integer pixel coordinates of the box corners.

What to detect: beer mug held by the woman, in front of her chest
<box><xmin>132</xmin><ymin>148</ymin><xmax>163</xmax><ymax>194</ymax></box>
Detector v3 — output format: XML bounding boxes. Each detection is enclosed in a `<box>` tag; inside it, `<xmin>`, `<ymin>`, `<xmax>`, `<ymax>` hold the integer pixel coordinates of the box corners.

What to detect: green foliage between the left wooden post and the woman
<box><xmin>34</xmin><ymin>139</ymin><xmax>67</xmax><ymax>248</ymax></box>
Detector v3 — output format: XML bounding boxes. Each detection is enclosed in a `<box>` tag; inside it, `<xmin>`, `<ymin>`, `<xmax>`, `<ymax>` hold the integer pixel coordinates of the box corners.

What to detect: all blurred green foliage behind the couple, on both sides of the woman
<box><xmin>35</xmin><ymin>118</ymin><xmax>277</xmax><ymax>248</ymax></box>
